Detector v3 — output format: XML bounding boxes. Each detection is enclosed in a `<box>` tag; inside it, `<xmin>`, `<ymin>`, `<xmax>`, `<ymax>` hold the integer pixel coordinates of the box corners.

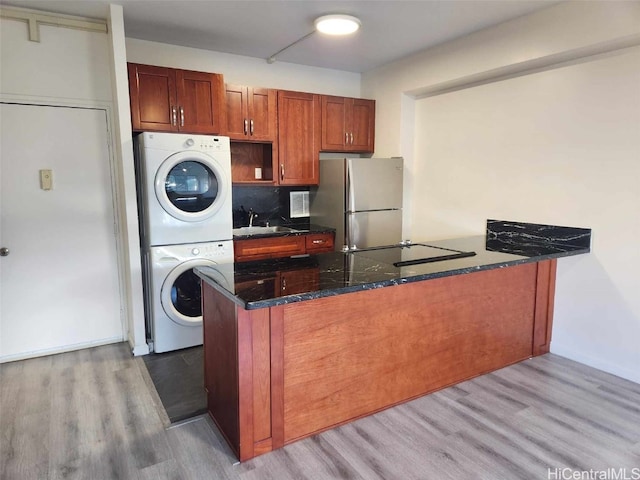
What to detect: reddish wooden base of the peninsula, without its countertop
<box><xmin>203</xmin><ymin>260</ymin><xmax>556</xmax><ymax>461</ymax></box>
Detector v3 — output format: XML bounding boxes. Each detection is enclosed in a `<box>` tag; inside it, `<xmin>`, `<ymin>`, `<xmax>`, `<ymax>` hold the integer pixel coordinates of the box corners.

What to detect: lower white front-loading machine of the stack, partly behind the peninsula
<box><xmin>145</xmin><ymin>240</ymin><xmax>234</xmax><ymax>353</ymax></box>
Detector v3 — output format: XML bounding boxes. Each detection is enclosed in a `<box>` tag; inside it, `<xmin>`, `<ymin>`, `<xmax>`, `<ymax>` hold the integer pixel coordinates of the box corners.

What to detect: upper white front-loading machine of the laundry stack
<box><xmin>136</xmin><ymin>132</ymin><xmax>233</xmax><ymax>247</ymax></box>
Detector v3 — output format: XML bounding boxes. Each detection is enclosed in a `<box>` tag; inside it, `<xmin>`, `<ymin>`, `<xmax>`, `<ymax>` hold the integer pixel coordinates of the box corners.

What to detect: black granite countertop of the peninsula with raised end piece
<box><xmin>194</xmin><ymin>220</ymin><xmax>591</xmax><ymax>310</ymax></box>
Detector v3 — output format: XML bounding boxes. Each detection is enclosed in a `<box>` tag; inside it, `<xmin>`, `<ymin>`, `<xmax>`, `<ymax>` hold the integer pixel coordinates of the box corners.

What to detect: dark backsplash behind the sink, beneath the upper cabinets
<box><xmin>232</xmin><ymin>185</ymin><xmax>309</xmax><ymax>228</ymax></box>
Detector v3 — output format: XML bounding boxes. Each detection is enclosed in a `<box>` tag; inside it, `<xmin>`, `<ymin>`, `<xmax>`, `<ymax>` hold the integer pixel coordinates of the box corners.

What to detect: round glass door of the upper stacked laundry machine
<box><xmin>155</xmin><ymin>151</ymin><xmax>229</xmax><ymax>222</ymax></box>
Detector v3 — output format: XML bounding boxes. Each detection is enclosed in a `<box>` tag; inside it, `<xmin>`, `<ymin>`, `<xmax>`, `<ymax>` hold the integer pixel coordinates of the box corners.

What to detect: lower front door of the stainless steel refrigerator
<box><xmin>347</xmin><ymin>210</ymin><xmax>402</xmax><ymax>248</ymax></box>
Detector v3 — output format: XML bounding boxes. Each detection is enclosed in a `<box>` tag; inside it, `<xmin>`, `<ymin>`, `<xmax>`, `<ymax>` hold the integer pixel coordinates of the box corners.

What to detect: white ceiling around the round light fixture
<box><xmin>0</xmin><ymin>0</ymin><xmax>558</xmax><ymax>72</ymax></box>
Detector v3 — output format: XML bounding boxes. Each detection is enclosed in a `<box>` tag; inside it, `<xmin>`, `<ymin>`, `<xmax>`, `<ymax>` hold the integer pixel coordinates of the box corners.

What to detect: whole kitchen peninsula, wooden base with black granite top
<box><xmin>196</xmin><ymin>220</ymin><xmax>591</xmax><ymax>461</ymax></box>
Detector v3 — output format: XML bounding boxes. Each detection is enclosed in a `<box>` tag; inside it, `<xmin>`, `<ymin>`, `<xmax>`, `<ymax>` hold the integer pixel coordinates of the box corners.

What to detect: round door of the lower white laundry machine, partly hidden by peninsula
<box><xmin>160</xmin><ymin>258</ymin><xmax>228</xmax><ymax>327</ymax></box>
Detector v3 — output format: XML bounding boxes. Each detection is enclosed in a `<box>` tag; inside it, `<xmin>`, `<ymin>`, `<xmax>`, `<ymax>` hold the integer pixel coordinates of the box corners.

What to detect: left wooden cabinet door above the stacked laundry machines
<box><xmin>128</xmin><ymin>63</ymin><xmax>178</xmax><ymax>132</ymax></box>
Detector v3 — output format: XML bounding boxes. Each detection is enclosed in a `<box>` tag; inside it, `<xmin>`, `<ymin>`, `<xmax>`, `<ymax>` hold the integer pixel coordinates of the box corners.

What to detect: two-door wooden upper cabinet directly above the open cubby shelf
<box><xmin>226</xmin><ymin>84</ymin><xmax>278</xmax><ymax>142</ymax></box>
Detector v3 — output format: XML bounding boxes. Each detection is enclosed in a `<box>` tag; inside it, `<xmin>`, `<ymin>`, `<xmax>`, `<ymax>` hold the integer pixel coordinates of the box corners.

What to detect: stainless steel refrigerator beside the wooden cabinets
<box><xmin>309</xmin><ymin>157</ymin><xmax>404</xmax><ymax>250</ymax></box>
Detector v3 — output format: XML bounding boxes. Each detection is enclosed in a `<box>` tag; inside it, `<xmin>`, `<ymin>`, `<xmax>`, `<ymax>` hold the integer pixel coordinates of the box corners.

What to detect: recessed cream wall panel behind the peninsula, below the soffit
<box><xmin>411</xmin><ymin>47</ymin><xmax>640</xmax><ymax>381</ymax></box>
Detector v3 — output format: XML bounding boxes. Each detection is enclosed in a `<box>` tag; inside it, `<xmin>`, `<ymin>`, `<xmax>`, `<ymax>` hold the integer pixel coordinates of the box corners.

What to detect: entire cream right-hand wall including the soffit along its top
<box><xmin>362</xmin><ymin>2</ymin><xmax>640</xmax><ymax>382</ymax></box>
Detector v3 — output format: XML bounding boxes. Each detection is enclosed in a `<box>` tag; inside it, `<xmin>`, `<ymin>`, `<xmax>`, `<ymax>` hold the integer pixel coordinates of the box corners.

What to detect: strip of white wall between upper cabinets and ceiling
<box><xmin>126</xmin><ymin>38</ymin><xmax>360</xmax><ymax>97</ymax></box>
